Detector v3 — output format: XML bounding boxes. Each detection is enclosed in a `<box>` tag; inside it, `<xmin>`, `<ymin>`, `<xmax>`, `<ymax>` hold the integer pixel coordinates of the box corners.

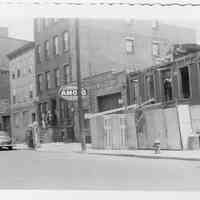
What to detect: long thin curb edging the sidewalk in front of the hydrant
<box><xmin>87</xmin><ymin>152</ymin><xmax>200</xmax><ymax>161</ymax></box>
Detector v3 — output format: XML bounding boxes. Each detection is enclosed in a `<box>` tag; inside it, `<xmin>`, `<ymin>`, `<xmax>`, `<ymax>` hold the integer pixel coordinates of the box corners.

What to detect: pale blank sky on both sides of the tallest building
<box><xmin>0</xmin><ymin>17</ymin><xmax>200</xmax><ymax>44</ymax></box>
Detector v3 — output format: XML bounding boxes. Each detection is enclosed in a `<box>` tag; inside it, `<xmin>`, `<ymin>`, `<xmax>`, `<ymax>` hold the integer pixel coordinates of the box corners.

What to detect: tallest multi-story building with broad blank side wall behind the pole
<box><xmin>34</xmin><ymin>19</ymin><xmax>196</xmax><ymax>141</ymax></box>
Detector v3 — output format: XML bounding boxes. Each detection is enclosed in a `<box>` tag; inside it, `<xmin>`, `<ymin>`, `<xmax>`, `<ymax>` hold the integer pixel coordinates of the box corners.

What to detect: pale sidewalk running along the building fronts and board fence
<box><xmin>16</xmin><ymin>143</ymin><xmax>200</xmax><ymax>161</ymax></box>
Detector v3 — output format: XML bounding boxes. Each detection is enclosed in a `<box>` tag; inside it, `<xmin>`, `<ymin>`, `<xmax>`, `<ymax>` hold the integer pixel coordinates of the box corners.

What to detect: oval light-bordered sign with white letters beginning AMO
<box><xmin>58</xmin><ymin>85</ymin><xmax>87</xmax><ymax>101</ymax></box>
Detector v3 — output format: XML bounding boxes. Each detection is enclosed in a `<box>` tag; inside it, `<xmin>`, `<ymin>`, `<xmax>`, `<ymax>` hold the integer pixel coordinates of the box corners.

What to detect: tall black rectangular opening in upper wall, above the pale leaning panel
<box><xmin>180</xmin><ymin>67</ymin><xmax>190</xmax><ymax>99</ymax></box>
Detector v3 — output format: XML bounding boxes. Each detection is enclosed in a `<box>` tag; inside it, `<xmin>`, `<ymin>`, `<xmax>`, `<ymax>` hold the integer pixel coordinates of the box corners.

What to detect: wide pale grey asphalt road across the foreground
<box><xmin>0</xmin><ymin>150</ymin><xmax>200</xmax><ymax>190</ymax></box>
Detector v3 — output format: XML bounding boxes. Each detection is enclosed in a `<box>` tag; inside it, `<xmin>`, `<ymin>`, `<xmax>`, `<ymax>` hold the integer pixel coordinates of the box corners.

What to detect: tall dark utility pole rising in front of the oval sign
<box><xmin>75</xmin><ymin>18</ymin><xmax>86</xmax><ymax>152</ymax></box>
